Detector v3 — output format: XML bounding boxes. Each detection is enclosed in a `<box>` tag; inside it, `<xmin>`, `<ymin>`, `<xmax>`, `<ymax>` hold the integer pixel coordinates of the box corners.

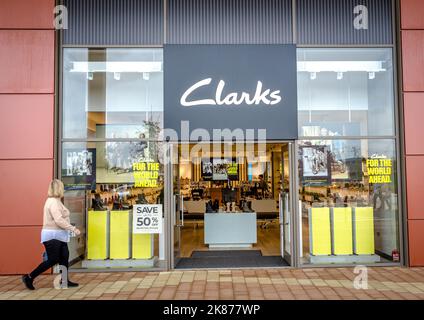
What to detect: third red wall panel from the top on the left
<box><xmin>0</xmin><ymin>94</ymin><xmax>54</xmax><ymax>159</ymax></box>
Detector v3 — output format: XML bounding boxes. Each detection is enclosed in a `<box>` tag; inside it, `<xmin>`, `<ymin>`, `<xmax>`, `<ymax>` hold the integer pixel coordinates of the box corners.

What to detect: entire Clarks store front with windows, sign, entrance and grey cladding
<box><xmin>57</xmin><ymin>0</ymin><xmax>404</xmax><ymax>271</ymax></box>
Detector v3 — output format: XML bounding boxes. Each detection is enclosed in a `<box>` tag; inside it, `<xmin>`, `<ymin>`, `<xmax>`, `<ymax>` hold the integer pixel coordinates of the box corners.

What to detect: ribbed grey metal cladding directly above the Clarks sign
<box><xmin>167</xmin><ymin>0</ymin><xmax>292</xmax><ymax>44</ymax></box>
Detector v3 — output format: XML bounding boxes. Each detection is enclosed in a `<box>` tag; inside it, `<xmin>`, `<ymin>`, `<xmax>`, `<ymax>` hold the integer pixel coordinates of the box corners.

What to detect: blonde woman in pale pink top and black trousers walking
<box><xmin>22</xmin><ymin>180</ymin><xmax>80</xmax><ymax>290</ymax></box>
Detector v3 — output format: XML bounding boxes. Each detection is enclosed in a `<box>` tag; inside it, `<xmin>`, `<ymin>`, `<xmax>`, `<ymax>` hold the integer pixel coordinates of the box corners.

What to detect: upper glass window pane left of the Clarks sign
<box><xmin>63</xmin><ymin>48</ymin><xmax>163</xmax><ymax>140</ymax></box>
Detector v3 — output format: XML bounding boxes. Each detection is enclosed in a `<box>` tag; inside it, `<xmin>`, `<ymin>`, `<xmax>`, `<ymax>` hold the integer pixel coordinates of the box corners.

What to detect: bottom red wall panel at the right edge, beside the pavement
<box><xmin>408</xmin><ymin>220</ymin><xmax>424</xmax><ymax>267</ymax></box>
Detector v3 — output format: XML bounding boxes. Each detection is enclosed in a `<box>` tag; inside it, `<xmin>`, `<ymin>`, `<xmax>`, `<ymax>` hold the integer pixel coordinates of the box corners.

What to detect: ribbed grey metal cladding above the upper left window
<box><xmin>63</xmin><ymin>0</ymin><xmax>164</xmax><ymax>45</ymax></box>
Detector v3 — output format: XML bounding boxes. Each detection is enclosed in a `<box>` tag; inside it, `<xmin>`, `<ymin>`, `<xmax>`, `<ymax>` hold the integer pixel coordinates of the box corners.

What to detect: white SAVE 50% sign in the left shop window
<box><xmin>133</xmin><ymin>204</ymin><xmax>163</xmax><ymax>234</ymax></box>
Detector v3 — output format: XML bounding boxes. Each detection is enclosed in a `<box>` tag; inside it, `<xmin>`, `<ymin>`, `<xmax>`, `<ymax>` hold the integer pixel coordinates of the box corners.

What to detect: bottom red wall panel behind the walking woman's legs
<box><xmin>0</xmin><ymin>226</ymin><xmax>44</xmax><ymax>275</ymax></box>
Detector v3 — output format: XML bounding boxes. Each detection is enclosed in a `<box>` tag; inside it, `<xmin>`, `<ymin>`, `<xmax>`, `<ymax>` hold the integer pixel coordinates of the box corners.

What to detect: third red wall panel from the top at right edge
<box><xmin>404</xmin><ymin>93</ymin><xmax>424</xmax><ymax>155</ymax></box>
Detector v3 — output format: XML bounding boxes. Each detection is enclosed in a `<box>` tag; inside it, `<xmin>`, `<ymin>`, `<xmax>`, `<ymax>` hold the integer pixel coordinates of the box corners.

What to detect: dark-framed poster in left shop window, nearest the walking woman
<box><xmin>62</xmin><ymin>148</ymin><xmax>96</xmax><ymax>190</ymax></box>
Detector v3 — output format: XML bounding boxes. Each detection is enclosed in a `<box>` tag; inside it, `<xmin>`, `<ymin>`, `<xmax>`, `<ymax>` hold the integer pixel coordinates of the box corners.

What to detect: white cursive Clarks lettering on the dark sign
<box><xmin>180</xmin><ymin>78</ymin><xmax>282</xmax><ymax>107</ymax></box>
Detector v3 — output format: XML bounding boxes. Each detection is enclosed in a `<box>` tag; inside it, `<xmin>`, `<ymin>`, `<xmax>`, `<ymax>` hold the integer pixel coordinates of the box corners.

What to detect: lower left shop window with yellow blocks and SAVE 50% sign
<box><xmin>61</xmin><ymin>140</ymin><xmax>166</xmax><ymax>269</ymax></box>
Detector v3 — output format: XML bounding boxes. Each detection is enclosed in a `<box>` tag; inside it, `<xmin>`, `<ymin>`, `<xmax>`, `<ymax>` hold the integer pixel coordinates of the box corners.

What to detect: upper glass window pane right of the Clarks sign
<box><xmin>297</xmin><ymin>48</ymin><xmax>395</xmax><ymax>137</ymax></box>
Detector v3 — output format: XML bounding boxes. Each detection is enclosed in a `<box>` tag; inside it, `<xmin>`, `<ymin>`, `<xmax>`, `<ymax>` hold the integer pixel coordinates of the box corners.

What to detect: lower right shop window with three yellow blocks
<box><xmin>298</xmin><ymin>139</ymin><xmax>400</xmax><ymax>264</ymax></box>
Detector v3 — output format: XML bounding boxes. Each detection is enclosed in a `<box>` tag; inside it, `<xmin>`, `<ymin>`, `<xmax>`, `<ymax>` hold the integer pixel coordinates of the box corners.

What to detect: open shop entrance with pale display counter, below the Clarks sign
<box><xmin>170</xmin><ymin>142</ymin><xmax>294</xmax><ymax>269</ymax></box>
